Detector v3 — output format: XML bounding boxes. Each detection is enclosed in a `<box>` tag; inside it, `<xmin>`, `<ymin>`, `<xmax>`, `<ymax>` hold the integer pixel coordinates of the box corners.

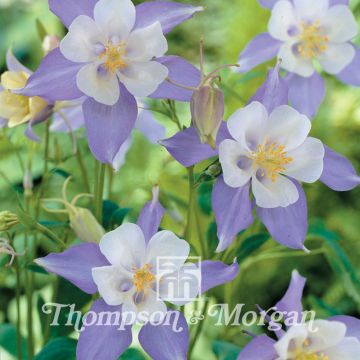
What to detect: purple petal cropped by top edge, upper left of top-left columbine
<box><xmin>49</xmin><ymin>0</ymin><xmax>99</xmax><ymax>27</ymax></box>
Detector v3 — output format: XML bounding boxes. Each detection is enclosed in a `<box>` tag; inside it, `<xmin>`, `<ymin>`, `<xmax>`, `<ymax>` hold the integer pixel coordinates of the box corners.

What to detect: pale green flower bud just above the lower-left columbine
<box><xmin>67</xmin><ymin>206</ymin><xmax>105</xmax><ymax>243</ymax></box>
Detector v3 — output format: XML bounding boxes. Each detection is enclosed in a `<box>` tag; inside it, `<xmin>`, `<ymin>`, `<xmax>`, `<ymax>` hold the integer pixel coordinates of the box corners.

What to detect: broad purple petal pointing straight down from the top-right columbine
<box><xmin>287</xmin><ymin>73</ymin><xmax>326</xmax><ymax>119</ymax></box>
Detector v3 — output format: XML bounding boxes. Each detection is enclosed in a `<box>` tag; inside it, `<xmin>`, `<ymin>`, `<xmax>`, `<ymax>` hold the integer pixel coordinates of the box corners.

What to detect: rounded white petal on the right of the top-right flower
<box><xmin>321</xmin><ymin>5</ymin><xmax>358</xmax><ymax>42</ymax></box>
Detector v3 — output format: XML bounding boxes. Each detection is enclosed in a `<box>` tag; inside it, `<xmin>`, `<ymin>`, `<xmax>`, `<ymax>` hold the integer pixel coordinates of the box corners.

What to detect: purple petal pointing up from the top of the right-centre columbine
<box><xmin>250</xmin><ymin>63</ymin><xmax>289</xmax><ymax>114</ymax></box>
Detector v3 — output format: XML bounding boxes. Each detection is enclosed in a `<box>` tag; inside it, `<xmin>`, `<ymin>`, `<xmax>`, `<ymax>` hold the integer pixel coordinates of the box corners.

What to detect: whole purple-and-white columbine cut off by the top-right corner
<box><xmin>238</xmin><ymin>0</ymin><xmax>360</xmax><ymax>119</ymax></box>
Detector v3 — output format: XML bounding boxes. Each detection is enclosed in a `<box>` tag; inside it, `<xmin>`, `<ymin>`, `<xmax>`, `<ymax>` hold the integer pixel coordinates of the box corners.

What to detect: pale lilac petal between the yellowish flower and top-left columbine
<box><xmin>50</xmin><ymin>101</ymin><xmax>85</xmax><ymax>133</ymax></box>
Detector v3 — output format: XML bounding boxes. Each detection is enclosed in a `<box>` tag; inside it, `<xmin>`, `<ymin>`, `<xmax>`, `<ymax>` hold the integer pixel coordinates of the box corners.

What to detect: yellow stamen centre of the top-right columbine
<box><xmin>297</xmin><ymin>21</ymin><xmax>329</xmax><ymax>60</ymax></box>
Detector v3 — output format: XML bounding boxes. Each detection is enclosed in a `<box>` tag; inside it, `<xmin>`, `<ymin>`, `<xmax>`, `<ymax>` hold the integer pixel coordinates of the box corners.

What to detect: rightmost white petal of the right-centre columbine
<box><xmin>284</xmin><ymin>137</ymin><xmax>325</xmax><ymax>183</ymax></box>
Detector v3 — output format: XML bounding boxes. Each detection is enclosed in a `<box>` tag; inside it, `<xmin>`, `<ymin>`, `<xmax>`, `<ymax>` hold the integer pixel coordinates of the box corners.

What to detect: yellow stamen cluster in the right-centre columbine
<box><xmin>250</xmin><ymin>140</ymin><xmax>293</xmax><ymax>182</ymax></box>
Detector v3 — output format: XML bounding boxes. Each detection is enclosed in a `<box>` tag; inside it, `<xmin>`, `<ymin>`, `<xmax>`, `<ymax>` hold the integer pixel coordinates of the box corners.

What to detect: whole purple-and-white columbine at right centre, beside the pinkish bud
<box><xmin>161</xmin><ymin>66</ymin><xmax>360</xmax><ymax>251</ymax></box>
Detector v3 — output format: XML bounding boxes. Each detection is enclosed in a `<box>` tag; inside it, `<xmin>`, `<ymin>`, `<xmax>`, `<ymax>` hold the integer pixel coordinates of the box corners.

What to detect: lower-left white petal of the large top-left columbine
<box><xmin>76</xmin><ymin>63</ymin><xmax>120</xmax><ymax>106</ymax></box>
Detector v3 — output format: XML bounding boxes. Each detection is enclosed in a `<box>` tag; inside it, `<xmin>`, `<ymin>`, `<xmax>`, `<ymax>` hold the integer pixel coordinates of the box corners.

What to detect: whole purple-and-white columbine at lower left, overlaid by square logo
<box><xmin>36</xmin><ymin>189</ymin><xmax>239</xmax><ymax>360</ymax></box>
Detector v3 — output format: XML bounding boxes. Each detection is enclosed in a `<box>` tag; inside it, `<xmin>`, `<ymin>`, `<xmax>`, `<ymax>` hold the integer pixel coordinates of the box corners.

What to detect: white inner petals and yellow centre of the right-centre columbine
<box><xmin>219</xmin><ymin>102</ymin><xmax>325</xmax><ymax>208</ymax></box>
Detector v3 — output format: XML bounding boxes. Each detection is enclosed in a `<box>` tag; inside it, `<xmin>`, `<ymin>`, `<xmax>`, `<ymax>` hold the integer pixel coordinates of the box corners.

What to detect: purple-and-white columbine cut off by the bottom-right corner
<box><xmin>237</xmin><ymin>271</ymin><xmax>360</xmax><ymax>360</ymax></box>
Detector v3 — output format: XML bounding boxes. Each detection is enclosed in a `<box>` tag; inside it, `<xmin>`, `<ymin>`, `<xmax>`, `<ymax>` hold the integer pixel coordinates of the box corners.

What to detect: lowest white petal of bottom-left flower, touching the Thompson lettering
<box><xmin>122</xmin><ymin>289</ymin><xmax>167</xmax><ymax>322</ymax></box>
